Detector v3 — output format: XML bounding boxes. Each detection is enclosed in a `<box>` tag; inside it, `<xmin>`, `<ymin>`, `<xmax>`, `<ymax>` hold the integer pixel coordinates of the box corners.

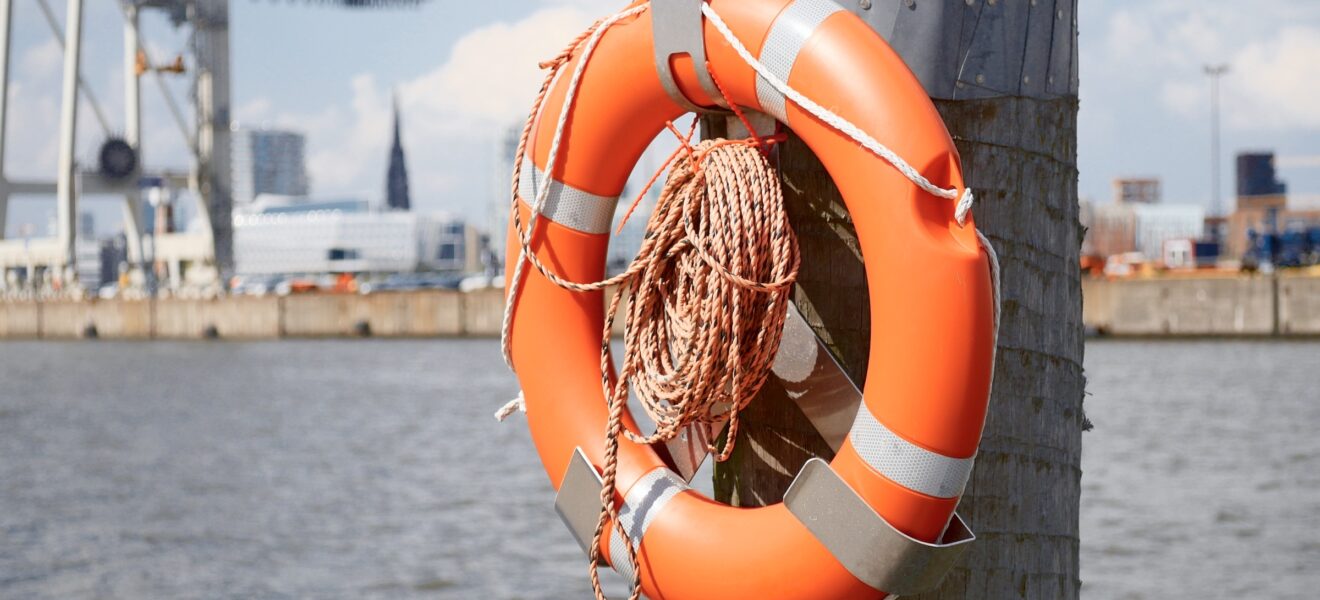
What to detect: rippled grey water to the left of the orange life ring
<box><xmin>0</xmin><ymin>340</ymin><xmax>628</xmax><ymax>599</ymax></box>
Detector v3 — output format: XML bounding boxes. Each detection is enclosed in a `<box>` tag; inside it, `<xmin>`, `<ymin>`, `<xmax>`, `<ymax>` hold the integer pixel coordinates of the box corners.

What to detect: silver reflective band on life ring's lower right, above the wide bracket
<box><xmin>849</xmin><ymin>402</ymin><xmax>975</xmax><ymax>498</ymax></box>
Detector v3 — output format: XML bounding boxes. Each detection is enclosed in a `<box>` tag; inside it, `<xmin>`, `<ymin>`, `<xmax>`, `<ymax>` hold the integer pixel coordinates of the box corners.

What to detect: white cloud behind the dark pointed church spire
<box><xmin>235</xmin><ymin>3</ymin><xmax>595</xmax><ymax>209</ymax></box>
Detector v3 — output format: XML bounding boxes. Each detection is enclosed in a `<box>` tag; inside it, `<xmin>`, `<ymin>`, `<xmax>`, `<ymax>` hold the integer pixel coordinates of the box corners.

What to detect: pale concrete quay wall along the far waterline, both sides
<box><xmin>0</xmin><ymin>272</ymin><xmax>1320</xmax><ymax>339</ymax></box>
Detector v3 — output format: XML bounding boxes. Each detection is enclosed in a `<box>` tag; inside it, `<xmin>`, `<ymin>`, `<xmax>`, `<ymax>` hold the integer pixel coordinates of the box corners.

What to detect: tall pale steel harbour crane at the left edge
<box><xmin>0</xmin><ymin>0</ymin><xmax>425</xmax><ymax>290</ymax></box>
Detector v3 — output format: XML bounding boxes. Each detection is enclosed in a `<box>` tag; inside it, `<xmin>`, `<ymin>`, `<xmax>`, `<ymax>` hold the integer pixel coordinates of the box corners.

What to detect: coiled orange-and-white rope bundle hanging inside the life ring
<box><xmin>590</xmin><ymin>140</ymin><xmax>800</xmax><ymax>600</ymax></box>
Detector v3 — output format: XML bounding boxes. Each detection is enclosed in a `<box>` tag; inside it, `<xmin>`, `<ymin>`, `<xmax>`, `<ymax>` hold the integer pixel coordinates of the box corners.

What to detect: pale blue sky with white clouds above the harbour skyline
<box><xmin>5</xmin><ymin>0</ymin><xmax>1320</xmax><ymax>240</ymax></box>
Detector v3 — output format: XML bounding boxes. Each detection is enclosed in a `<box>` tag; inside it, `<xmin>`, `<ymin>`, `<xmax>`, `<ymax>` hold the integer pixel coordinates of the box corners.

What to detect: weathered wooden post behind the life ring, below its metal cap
<box><xmin>704</xmin><ymin>3</ymin><xmax>1085</xmax><ymax>599</ymax></box>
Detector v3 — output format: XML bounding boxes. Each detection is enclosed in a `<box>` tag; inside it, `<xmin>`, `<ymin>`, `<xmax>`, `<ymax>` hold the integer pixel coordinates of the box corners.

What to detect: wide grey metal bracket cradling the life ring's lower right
<box><xmin>784</xmin><ymin>459</ymin><xmax>975</xmax><ymax>596</ymax></box>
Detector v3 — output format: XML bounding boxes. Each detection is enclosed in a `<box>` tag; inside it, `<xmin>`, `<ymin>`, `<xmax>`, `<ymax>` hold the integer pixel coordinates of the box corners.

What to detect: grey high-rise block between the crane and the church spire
<box><xmin>231</xmin><ymin>128</ymin><xmax>309</xmax><ymax>207</ymax></box>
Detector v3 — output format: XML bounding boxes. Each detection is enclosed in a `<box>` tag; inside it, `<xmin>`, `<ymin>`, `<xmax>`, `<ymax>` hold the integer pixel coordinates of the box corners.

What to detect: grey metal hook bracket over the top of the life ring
<box><xmin>651</xmin><ymin>0</ymin><xmax>727</xmax><ymax>112</ymax></box>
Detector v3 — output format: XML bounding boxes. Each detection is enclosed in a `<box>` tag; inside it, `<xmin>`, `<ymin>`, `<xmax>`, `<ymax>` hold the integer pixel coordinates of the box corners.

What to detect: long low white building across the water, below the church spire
<box><xmin>234</xmin><ymin>196</ymin><xmax>484</xmax><ymax>276</ymax></box>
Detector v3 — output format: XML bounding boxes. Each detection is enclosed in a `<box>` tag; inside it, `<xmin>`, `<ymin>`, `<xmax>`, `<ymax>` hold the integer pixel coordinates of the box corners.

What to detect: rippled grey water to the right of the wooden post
<box><xmin>1081</xmin><ymin>342</ymin><xmax>1320</xmax><ymax>599</ymax></box>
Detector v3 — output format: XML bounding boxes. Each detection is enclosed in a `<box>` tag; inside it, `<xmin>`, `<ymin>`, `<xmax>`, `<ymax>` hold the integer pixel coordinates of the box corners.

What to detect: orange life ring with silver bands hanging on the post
<box><xmin>507</xmin><ymin>0</ymin><xmax>995</xmax><ymax>600</ymax></box>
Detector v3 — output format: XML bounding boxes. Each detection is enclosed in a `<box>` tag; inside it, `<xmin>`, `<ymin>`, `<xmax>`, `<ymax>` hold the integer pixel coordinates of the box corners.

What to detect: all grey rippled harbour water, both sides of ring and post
<box><xmin>0</xmin><ymin>340</ymin><xmax>1320</xmax><ymax>599</ymax></box>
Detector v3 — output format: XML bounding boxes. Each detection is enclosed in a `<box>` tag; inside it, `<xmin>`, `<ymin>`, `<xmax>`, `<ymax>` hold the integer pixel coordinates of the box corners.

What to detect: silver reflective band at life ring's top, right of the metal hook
<box><xmin>756</xmin><ymin>0</ymin><xmax>843</xmax><ymax>123</ymax></box>
